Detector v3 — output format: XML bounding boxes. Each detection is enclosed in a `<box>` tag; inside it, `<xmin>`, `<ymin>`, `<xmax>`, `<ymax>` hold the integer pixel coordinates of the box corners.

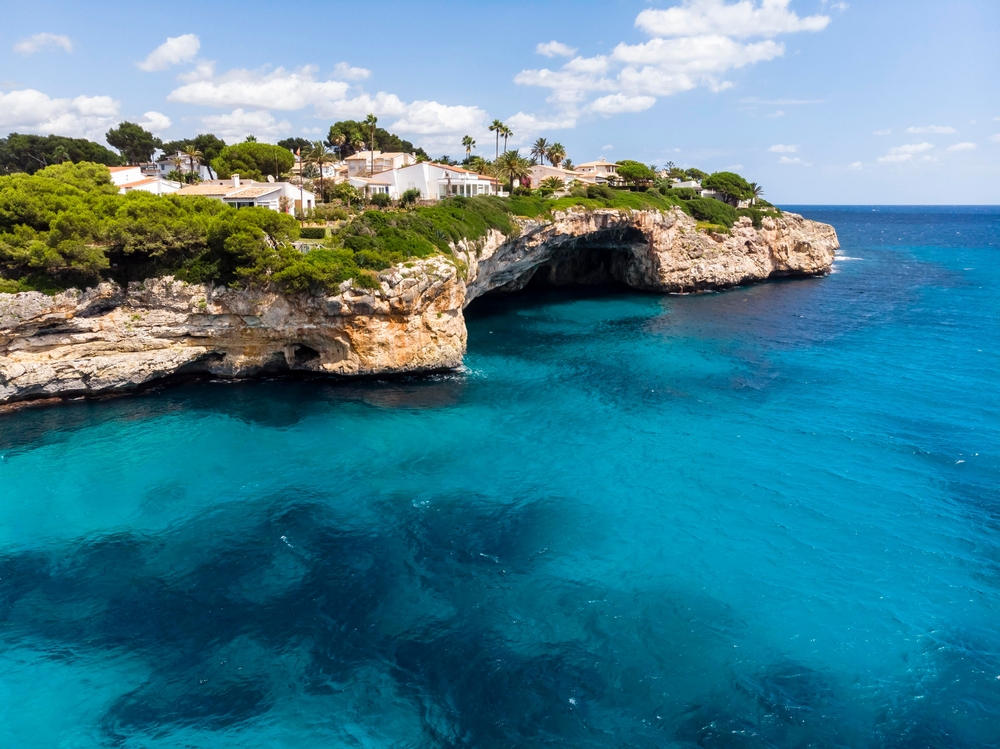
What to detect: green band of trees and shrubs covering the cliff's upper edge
<box><xmin>0</xmin><ymin>163</ymin><xmax>744</xmax><ymax>293</ymax></box>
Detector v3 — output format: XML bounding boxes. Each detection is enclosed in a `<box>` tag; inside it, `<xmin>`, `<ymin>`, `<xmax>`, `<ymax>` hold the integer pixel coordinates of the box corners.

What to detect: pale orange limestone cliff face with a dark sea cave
<box><xmin>0</xmin><ymin>205</ymin><xmax>839</xmax><ymax>404</ymax></box>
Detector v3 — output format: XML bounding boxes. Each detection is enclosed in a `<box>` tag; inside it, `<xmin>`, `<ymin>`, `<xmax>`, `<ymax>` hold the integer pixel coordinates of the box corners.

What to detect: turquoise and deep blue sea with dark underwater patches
<box><xmin>0</xmin><ymin>207</ymin><xmax>1000</xmax><ymax>749</ymax></box>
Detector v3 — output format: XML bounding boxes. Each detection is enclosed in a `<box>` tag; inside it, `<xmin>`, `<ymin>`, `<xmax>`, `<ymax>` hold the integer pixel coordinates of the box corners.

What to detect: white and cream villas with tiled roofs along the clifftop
<box><xmin>111</xmin><ymin>151</ymin><xmax>744</xmax><ymax>213</ymax></box>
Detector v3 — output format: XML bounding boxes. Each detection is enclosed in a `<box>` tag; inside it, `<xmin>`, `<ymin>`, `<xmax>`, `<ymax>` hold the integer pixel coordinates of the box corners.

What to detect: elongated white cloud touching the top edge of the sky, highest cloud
<box><xmin>635</xmin><ymin>0</ymin><xmax>830</xmax><ymax>38</ymax></box>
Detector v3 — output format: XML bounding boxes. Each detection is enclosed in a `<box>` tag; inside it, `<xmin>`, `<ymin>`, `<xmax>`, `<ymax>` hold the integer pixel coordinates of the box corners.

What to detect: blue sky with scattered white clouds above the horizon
<box><xmin>0</xmin><ymin>0</ymin><xmax>1000</xmax><ymax>204</ymax></box>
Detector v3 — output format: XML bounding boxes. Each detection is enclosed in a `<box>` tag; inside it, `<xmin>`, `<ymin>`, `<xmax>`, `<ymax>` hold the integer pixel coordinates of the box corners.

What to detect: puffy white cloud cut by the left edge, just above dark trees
<box><xmin>0</xmin><ymin>88</ymin><xmax>120</xmax><ymax>141</ymax></box>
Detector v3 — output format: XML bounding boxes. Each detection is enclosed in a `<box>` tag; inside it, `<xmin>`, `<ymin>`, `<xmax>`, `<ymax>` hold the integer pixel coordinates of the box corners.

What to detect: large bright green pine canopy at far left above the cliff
<box><xmin>0</xmin><ymin>163</ymin><xmax>299</xmax><ymax>292</ymax></box>
